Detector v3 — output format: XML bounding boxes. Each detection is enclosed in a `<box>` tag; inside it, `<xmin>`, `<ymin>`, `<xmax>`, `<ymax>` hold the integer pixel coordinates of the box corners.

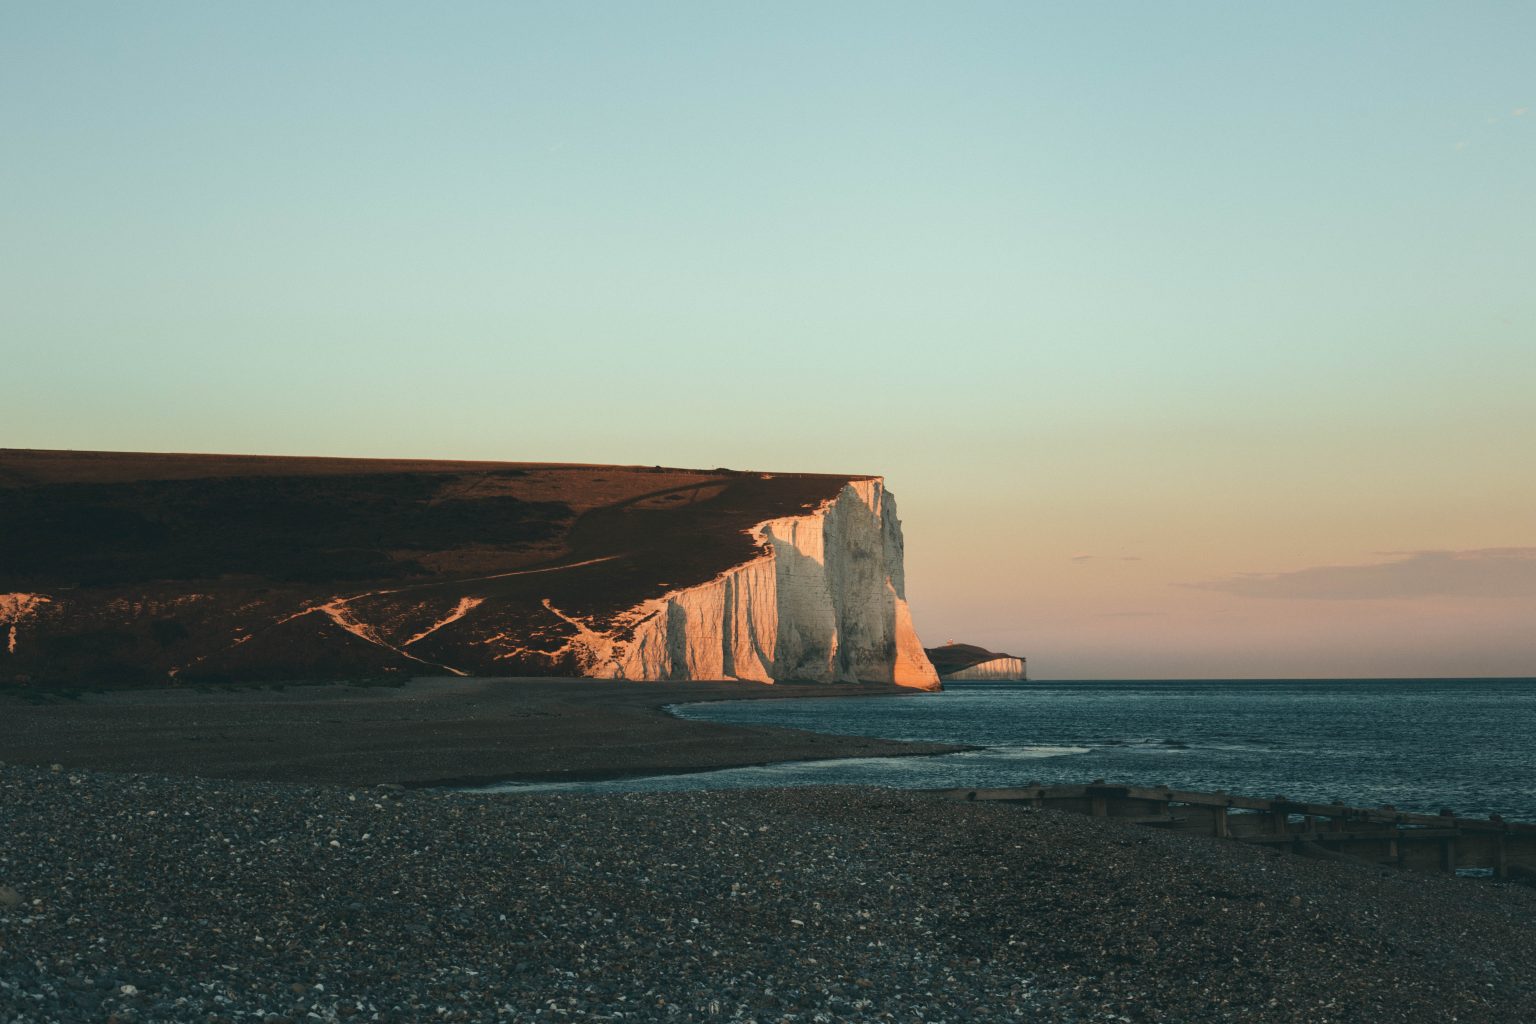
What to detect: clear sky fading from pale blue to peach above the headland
<box><xmin>0</xmin><ymin>0</ymin><xmax>1536</xmax><ymax>679</ymax></box>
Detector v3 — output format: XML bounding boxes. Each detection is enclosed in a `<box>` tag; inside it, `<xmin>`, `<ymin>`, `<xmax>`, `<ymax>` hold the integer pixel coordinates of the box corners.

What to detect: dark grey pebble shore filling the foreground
<box><xmin>0</xmin><ymin>765</ymin><xmax>1536</xmax><ymax>1024</ymax></box>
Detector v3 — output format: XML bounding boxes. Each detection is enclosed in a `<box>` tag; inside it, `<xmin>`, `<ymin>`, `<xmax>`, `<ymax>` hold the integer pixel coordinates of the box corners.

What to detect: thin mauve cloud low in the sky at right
<box><xmin>1180</xmin><ymin>548</ymin><xmax>1536</xmax><ymax>600</ymax></box>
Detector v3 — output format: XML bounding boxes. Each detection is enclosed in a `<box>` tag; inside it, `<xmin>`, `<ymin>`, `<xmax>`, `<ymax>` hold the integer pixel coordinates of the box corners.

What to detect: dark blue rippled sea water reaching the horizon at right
<box><xmin>476</xmin><ymin>679</ymin><xmax>1536</xmax><ymax>821</ymax></box>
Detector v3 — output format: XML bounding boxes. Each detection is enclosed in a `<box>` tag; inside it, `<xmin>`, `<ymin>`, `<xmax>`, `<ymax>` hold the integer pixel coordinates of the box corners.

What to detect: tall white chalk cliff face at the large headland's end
<box><xmin>550</xmin><ymin>477</ymin><xmax>940</xmax><ymax>689</ymax></box>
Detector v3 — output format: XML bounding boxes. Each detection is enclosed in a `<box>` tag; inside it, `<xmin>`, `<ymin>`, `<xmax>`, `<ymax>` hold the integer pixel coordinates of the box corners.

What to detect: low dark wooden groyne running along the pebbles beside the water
<box><xmin>935</xmin><ymin>780</ymin><xmax>1536</xmax><ymax>883</ymax></box>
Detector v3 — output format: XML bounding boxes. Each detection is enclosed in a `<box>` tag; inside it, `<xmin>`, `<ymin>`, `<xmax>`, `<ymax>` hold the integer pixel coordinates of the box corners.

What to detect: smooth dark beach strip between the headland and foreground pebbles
<box><xmin>0</xmin><ymin>679</ymin><xmax>963</xmax><ymax>786</ymax></box>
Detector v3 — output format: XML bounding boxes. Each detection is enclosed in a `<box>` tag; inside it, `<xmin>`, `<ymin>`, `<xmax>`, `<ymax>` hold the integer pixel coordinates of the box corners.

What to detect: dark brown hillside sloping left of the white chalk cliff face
<box><xmin>0</xmin><ymin>450</ymin><xmax>849</xmax><ymax>685</ymax></box>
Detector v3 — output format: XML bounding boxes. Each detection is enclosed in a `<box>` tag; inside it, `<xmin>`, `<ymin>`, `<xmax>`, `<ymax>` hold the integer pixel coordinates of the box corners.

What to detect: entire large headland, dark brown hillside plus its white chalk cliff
<box><xmin>0</xmin><ymin>450</ymin><xmax>940</xmax><ymax>689</ymax></box>
